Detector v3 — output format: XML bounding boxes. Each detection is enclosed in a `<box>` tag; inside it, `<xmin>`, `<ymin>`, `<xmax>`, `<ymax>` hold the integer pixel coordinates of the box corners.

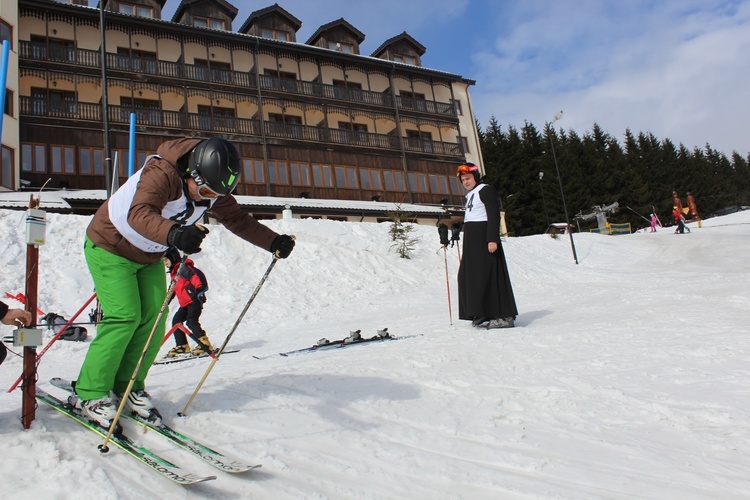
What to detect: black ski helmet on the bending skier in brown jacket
<box><xmin>188</xmin><ymin>137</ymin><xmax>241</xmax><ymax>195</ymax></box>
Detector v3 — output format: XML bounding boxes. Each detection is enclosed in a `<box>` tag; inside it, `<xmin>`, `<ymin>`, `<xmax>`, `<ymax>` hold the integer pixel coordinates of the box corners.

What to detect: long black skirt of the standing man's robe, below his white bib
<box><xmin>458</xmin><ymin>222</ymin><xmax>518</xmax><ymax>320</ymax></box>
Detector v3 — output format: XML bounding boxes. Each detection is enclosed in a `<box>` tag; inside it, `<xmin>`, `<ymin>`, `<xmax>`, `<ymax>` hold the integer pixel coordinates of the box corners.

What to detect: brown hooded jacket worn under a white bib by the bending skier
<box><xmin>86</xmin><ymin>139</ymin><xmax>277</xmax><ymax>264</ymax></box>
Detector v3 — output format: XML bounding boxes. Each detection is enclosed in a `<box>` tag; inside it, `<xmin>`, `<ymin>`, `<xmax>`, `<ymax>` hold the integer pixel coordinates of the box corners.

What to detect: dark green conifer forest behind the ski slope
<box><xmin>478</xmin><ymin>117</ymin><xmax>750</xmax><ymax>236</ymax></box>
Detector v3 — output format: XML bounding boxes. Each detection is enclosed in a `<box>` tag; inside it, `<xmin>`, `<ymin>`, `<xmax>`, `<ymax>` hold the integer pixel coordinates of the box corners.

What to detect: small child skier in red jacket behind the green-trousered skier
<box><xmin>164</xmin><ymin>247</ymin><xmax>214</xmax><ymax>357</ymax></box>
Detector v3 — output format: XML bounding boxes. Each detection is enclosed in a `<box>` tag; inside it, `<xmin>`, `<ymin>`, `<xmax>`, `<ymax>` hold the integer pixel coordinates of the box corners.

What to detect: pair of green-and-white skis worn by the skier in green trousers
<box><xmin>36</xmin><ymin>378</ymin><xmax>260</xmax><ymax>485</ymax></box>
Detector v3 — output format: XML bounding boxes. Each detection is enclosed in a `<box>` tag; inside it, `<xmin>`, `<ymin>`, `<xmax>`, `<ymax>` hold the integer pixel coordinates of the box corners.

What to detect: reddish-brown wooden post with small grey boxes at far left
<box><xmin>21</xmin><ymin>195</ymin><xmax>39</xmax><ymax>429</ymax></box>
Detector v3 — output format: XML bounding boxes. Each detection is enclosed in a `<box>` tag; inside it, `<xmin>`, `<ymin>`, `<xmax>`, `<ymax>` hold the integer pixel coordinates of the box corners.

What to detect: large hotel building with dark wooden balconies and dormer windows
<box><xmin>2</xmin><ymin>0</ymin><xmax>481</xmax><ymax>219</ymax></box>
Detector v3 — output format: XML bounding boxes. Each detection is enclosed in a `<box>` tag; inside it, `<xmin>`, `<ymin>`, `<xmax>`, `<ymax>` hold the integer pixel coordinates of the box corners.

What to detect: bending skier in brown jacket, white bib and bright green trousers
<box><xmin>69</xmin><ymin>137</ymin><xmax>294</xmax><ymax>428</ymax></box>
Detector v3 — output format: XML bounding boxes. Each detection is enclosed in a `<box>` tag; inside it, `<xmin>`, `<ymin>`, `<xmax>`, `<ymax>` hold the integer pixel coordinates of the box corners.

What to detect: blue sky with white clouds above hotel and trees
<box><xmin>164</xmin><ymin>0</ymin><xmax>750</xmax><ymax>157</ymax></box>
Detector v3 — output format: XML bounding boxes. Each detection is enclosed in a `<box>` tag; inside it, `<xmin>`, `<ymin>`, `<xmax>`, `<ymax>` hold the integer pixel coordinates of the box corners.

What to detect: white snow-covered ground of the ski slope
<box><xmin>0</xmin><ymin>210</ymin><xmax>750</xmax><ymax>499</ymax></box>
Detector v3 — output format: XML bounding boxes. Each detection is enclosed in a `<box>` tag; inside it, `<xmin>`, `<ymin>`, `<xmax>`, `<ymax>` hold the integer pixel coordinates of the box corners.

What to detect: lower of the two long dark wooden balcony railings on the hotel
<box><xmin>19</xmin><ymin>96</ymin><xmax>462</xmax><ymax>156</ymax></box>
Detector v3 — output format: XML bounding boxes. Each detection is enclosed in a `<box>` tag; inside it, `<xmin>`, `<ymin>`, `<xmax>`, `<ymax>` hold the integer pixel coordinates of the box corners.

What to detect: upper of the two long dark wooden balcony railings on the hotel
<box><xmin>19</xmin><ymin>40</ymin><xmax>457</xmax><ymax>117</ymax></box>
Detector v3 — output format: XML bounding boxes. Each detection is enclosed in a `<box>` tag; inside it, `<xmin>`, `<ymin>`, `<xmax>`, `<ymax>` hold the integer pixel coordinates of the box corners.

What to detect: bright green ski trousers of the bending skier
<box><xmin>76</xmin><ymin>238</ymin><xmax>167</xmax><ymax>401</ymax></box>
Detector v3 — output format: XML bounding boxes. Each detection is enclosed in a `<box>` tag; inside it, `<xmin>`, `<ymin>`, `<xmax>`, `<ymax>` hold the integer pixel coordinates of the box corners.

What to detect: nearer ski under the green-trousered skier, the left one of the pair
<box><xmin>36</xmin><ymin>387</ymin><xmax>216</xmax><ymax>485</ymax></box>
